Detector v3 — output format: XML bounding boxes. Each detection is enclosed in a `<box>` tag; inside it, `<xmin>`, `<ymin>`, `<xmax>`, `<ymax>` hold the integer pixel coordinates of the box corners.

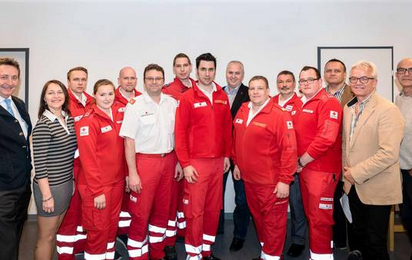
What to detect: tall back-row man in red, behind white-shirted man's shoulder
<box><xmin>162</xmin><ymin>53</ymin><xmax>196</xmax><ymax>260</ymax></box>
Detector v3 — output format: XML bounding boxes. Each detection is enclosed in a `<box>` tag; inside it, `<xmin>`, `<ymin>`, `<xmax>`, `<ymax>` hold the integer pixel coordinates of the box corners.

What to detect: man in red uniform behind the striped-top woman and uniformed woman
<box><xmin>56</xmin><ymin>67</ymin><xmax>94</xmax><ymax>260</ymax></box>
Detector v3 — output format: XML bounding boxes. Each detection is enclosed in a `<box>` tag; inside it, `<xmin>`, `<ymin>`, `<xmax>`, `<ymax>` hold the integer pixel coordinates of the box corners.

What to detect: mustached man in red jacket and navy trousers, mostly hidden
<box><xmin>273</xmin><ymin>70</ymin><xmax>306</xmax><ymax>257</ymax></box>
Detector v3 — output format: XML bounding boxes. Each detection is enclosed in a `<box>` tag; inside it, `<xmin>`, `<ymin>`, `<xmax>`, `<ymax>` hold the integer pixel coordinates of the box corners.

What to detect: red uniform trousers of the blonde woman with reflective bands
<box><xmin>79</xmin><ymin>180</ymin><xmax>124</xmax><ymax>260</ymax></box>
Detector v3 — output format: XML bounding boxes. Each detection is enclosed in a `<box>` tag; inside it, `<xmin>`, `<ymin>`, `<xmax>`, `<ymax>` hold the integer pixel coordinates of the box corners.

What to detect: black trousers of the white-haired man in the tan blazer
<box><xmin>349</xmin><ymin>186</ymin><xmax>392</xmax><ymax>260</ymax></box>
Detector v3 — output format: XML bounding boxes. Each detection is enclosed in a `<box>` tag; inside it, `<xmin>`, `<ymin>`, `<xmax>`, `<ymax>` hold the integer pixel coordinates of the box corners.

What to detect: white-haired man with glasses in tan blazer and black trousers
<box><xmin>342</xmin><ymin>61</ymin><xmax>404</xmax><ymax>260</ymax></box>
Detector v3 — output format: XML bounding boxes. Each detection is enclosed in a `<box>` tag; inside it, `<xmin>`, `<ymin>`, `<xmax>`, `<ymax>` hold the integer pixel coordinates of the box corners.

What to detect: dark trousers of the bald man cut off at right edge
<box><xmin>399</xmin><ymin>170</ymin><xmax>412</xmax><ymax>244</ymax></box>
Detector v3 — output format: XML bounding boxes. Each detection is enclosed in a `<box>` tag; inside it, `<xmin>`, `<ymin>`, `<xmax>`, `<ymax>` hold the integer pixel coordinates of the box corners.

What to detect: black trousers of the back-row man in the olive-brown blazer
<box><xmin>333</xmin><ymin>181</ymin><xmax>352</xmax><ymax>248</ymax></box>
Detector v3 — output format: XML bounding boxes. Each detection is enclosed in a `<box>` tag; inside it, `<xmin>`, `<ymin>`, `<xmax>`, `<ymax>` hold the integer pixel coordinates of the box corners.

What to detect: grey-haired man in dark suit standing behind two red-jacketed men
<box><xmin>218</xmin><ymin>61</ymin><xmax>250</xmax><ymax>251</ymax></box>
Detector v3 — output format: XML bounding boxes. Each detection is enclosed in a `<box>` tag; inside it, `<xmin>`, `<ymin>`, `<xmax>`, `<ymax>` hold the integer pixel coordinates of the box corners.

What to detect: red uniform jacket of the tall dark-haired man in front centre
<box><xmin>175</xmin><ymin>84</ymin><xmax>232</xmax><ymax>167</ymax></box>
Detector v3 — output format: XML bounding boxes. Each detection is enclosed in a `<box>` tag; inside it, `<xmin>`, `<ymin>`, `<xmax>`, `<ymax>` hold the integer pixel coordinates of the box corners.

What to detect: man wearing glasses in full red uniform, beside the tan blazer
<box><xmin>294</xmin><ymin>66</ymin><xmax>342</xmax><ymax>260</ymax></box>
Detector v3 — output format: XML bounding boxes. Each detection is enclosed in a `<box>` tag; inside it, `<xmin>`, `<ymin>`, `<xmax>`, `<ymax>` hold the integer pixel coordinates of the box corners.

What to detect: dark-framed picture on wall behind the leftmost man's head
<box><xmin>0</xmin><ymin>48</ymin><xmax>29</xmax><ymax>108</ymax></box>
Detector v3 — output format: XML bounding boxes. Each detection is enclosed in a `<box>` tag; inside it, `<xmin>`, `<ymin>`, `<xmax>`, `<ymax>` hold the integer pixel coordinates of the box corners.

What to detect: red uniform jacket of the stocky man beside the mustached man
<box><xmin>232</xmin><ymin>99</ymin><xmax>297</xmax><ymax>185</ymax></box>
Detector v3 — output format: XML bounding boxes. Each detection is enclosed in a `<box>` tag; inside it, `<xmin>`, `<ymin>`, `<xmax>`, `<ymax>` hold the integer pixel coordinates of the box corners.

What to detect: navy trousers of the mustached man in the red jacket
<box><xmin>289</xmin><ymin>174</ymin><xmax>307</xmax><ymax>245</ymax></box>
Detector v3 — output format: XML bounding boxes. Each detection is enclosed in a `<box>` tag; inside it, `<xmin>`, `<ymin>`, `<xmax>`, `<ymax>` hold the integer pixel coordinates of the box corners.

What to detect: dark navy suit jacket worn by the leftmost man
<box><xmin>0</xmin><ymin>96</ymin><xmax>32</xmax><ymax>191</ymax></box>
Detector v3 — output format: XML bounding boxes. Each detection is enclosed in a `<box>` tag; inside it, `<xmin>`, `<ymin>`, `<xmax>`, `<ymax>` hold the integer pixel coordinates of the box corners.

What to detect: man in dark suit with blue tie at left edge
<box><xmin>0</xmin><ymin>58</ymin><xmax>32</xmax><ymax>260</ymax></box>
